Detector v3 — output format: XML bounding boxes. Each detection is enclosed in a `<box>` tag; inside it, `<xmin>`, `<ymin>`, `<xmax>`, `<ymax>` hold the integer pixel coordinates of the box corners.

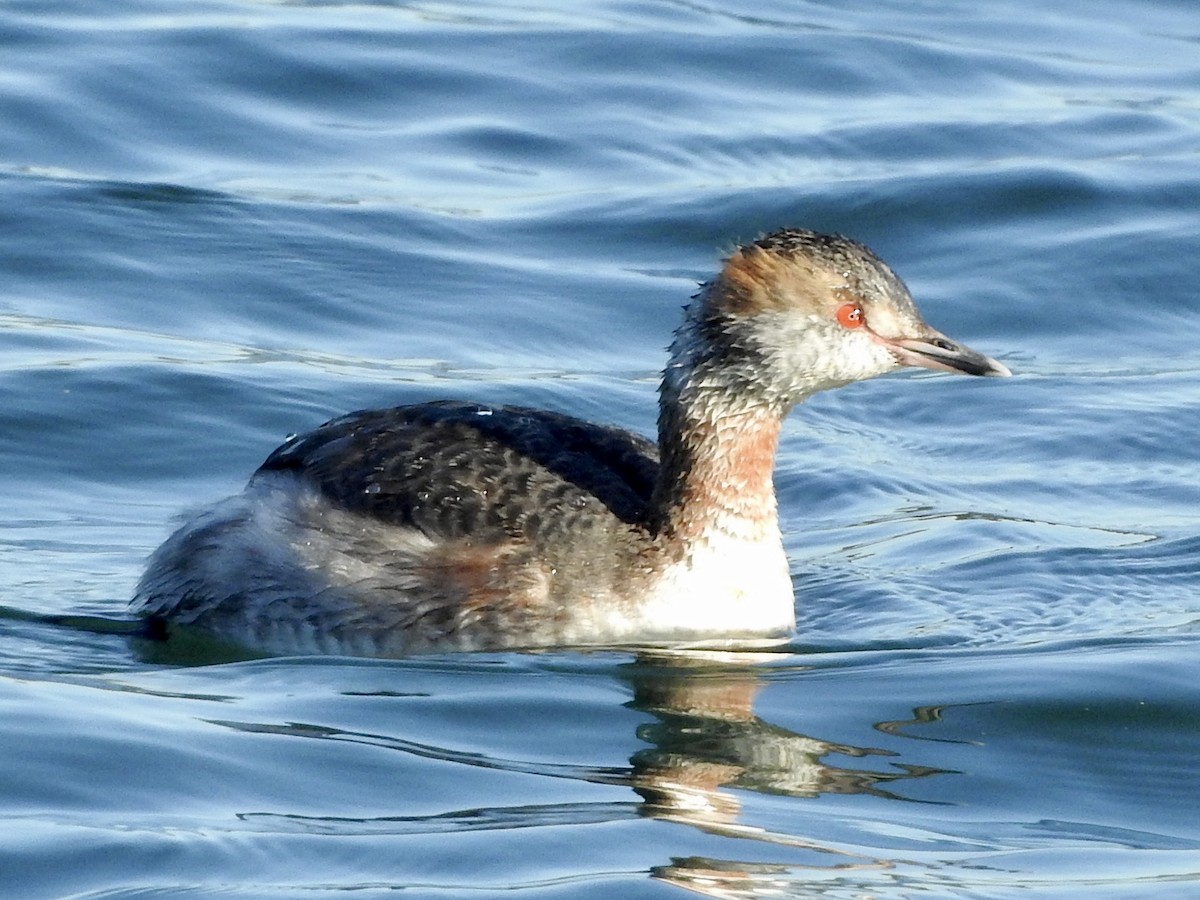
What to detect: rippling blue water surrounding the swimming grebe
<box><xmin>0</xmin><ymin>0</ymin><xmax>1200</xmax><ymax>900</ymax></box>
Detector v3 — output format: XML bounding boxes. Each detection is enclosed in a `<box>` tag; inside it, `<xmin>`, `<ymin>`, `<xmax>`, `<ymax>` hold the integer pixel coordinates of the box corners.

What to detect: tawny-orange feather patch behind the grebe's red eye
<box><xmin>719</xmin><ymin>245</ymin><xmax>847</xmax><ymax>316</ymax></box>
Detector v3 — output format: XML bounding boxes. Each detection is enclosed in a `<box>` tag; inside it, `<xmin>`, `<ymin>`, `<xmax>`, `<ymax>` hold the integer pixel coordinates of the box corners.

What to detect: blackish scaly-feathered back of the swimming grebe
<box><xmin>256</xmin><ymin>401</ymin><xmax>658</xmax><ymax>540</ymax></box>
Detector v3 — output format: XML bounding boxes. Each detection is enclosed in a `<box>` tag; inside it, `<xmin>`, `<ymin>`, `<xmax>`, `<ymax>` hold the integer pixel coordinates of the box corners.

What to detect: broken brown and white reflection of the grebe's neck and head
<box><xmin>624</xmin><ymin>653</ymin><xmax>944</xmax><ymax>898</ymax></box>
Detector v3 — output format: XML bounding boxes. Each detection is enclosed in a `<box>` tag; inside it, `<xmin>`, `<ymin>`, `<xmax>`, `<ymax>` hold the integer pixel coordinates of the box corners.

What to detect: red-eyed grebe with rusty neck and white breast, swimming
<box><xmin>133</xmin><ymin>229</ymin><xmax>1010</xmax><ymax>656</ymax></box>
